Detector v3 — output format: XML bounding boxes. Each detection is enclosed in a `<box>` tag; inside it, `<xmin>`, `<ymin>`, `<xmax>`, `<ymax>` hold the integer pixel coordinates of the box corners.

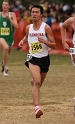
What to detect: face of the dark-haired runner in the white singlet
<box><xmin>31</xmin><ymin>8</ymin><xmax>42</xmax><ymax>21</ymax></box>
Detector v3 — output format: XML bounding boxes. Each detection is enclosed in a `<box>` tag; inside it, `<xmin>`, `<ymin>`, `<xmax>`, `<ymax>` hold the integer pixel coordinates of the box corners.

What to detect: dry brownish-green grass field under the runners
<box><xmin>0</xmin><ymin>50</ymin><xmax>75</xmax><ymax>124</ymax></box>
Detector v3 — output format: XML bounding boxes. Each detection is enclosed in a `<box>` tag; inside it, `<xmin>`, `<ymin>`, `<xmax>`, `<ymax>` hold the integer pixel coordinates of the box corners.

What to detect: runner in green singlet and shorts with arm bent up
<box><xmin>0</xmin><ymin>0</ymin><xmax>18</xmax><ymax>76</ymax></box>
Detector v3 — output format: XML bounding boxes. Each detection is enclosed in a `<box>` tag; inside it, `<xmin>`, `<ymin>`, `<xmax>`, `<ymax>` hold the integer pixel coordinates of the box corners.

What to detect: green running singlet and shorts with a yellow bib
<box><xmin>0</xmin><ymin>12</ymin><xmax>14</xmax><ymax>46</ymax></box>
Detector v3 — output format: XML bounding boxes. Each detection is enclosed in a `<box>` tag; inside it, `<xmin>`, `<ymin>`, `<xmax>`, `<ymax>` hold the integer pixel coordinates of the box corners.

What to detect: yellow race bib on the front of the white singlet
<box><xmin>30</xmin><ymin>42</ymin><xmax>43</xmax><ymax>53</ymax></box>
